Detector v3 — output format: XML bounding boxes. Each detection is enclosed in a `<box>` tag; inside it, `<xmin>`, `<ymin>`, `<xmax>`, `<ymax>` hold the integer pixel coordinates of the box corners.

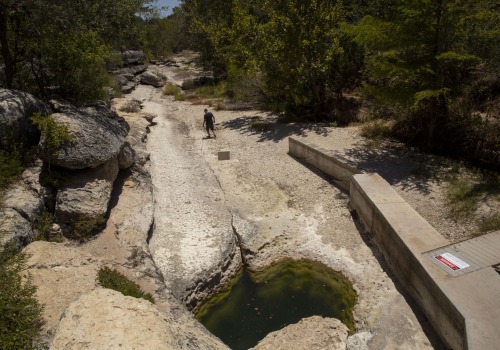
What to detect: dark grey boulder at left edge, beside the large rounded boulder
<box><xmin>0</xmin><ymin>89</ymin><xmax>51</xmax><ymax>149</ymax></box>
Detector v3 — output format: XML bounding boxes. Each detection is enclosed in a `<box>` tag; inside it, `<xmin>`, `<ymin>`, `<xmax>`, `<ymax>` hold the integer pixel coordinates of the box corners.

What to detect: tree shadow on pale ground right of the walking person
<box><xmin>221</xmin><ymin>114</ymin><xmax>331</xmax><ymax>142</ymax></box>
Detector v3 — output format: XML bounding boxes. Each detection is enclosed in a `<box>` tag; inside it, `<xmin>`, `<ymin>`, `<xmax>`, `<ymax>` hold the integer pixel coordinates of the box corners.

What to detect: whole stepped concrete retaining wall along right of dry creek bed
<box><xmin>289</xmin><ymin>138</ymin><xmax>500</xmax><ymax>350</ymax></box>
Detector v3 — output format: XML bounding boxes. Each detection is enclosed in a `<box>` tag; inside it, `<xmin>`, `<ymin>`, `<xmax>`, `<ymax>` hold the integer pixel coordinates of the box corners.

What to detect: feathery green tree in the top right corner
<box><xmin>347</xmin><ymin>0</ymin><xmax>500</xmax><ymax>151</ymax></box>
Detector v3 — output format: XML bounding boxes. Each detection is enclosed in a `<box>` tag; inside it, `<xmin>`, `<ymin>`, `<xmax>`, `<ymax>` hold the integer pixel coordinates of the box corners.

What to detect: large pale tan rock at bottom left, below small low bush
<box><xmin>51</xmin><ymin>288</ymin><xmax>227</xmax><ymax>350</ymax></box>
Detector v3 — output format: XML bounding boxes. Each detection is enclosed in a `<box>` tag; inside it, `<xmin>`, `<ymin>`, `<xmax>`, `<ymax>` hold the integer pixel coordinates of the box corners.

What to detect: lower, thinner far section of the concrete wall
<box><xmin>288</xmin><ymin>137</ymin><xmax>359</xmax><ymax>191</ymax></box>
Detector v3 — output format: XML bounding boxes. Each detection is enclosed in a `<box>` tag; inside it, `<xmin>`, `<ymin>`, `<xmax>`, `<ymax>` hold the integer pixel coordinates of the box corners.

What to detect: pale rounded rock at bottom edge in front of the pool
<box><xmin>253</xmin><ymin>316</ymin><xmax>349</xmax><ymax>350</ymax></box>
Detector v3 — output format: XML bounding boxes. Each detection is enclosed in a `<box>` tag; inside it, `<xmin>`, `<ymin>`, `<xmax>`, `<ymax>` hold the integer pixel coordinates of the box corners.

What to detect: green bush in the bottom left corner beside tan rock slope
<box><xmin>0</xmin><ymin>246</ymin><xmax>47</xmax><ymax>349</ymax></box>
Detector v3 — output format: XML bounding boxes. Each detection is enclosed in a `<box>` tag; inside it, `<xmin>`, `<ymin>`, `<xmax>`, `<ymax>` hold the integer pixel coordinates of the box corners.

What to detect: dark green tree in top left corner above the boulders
<box><xmin>0</xmin><ymin>0</ymin><xmax>156</xmax><ymax>102</ymax></box>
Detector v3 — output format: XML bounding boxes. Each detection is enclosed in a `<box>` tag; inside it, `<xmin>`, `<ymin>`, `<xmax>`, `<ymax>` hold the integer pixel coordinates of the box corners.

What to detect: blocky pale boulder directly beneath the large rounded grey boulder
<box><xmin>55</xmin><ymin>157</ymin><xmax>119</xmax><ymax>223</ymax></box>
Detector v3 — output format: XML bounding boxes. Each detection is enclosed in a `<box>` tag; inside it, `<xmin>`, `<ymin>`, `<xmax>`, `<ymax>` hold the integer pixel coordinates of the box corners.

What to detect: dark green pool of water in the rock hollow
<box><xmin>196</xmin><ymin>259</ymin><xmax>356</xmax><ymax>350</ymax></box>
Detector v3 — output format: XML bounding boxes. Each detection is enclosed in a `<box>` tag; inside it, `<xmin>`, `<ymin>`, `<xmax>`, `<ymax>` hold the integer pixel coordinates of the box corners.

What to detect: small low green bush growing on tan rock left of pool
<box><xmin>97</xmin><ymin>266</ymin><xmax>155</xmax><ymax>304</ymax></box>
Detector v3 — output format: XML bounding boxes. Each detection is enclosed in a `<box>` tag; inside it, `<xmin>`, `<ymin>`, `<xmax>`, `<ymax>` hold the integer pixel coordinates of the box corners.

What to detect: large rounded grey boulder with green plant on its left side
<box><xmin>40</xmin><ymin>105</ymin><xmax>129</xmax><ymax>169</ymax></box>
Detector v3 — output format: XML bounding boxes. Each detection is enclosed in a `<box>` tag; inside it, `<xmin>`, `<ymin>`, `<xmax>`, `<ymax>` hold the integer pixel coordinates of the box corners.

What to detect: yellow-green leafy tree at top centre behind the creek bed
<box><xmin>183</xmin><ymin>0</ymin><xmax>359</xmax><ymax>118</ymax></box>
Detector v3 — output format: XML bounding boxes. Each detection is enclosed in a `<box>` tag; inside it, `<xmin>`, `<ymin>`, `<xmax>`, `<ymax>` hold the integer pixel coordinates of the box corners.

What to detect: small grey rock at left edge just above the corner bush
<box><xmin>0</xmin><ymin>208</ymin><xmax>35</xmax><ymax>248</ymax></box>
